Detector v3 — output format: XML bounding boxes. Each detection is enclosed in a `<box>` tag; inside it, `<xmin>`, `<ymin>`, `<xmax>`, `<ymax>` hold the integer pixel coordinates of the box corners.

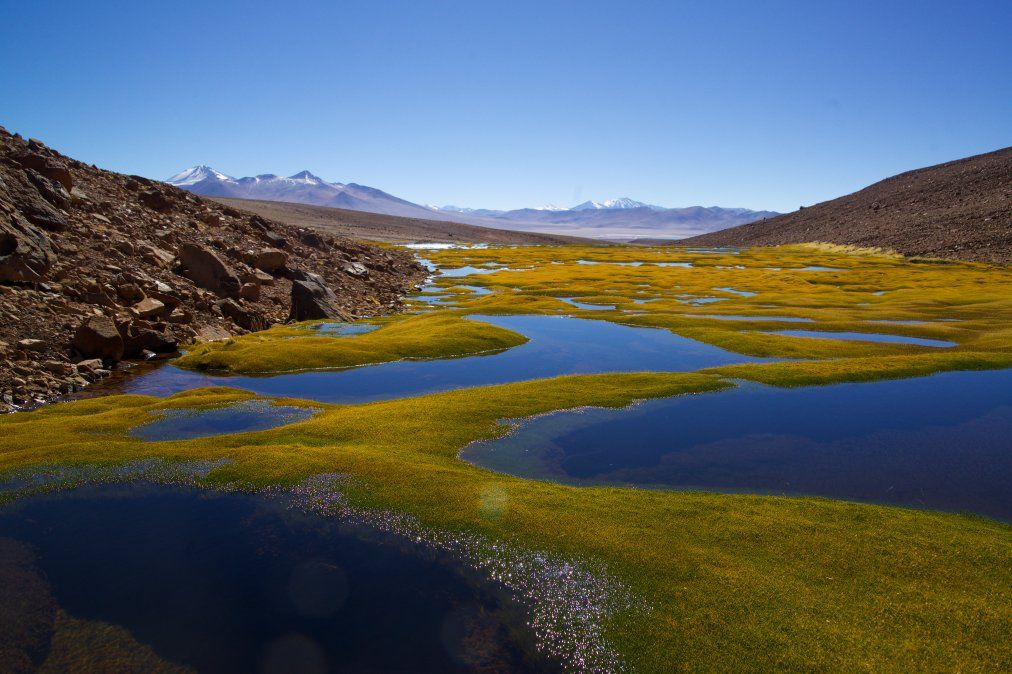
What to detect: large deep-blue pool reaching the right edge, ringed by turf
<box><xmin>461</xmin><ymin>370</ymin><xmax>1012</xmax><ymax>519</ymax></box>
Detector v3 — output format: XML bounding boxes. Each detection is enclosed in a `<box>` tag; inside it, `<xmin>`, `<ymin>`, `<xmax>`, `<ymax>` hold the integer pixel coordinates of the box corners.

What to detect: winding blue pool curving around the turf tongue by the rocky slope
<box><xmin>120</xmin><ymin>316</ymin><xmax>761</xmax><ymax>403</ymax></box>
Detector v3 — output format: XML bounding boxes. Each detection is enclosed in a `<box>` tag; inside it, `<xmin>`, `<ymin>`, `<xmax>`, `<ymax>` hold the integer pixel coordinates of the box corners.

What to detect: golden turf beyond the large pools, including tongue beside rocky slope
<box><xmin>177</xmin><ymin>244</ymin><xmax>1012</xmax><ymax>384</ymax></box>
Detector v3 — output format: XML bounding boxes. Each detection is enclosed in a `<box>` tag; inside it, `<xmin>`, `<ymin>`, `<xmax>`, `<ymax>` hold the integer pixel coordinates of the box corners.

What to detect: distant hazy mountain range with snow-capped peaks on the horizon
<box><xmin>165</xmin><ymin>165</ymin><xmax>778</xmax><ymax>239</ymax></box>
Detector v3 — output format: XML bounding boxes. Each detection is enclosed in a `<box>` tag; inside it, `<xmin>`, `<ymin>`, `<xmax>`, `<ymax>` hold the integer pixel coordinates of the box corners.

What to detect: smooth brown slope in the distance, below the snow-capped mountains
<box><xmin>209</xmin><ymin>197</ymin><xmax>593</xmax><ymax>244</ymax></box>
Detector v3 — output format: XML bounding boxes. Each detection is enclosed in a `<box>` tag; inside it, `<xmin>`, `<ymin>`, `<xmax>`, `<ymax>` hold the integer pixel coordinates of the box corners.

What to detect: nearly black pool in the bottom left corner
<box><xmin>0</xmin><ymin>484</ymin><xmax>556</xmax><ymax>673</ymax></box>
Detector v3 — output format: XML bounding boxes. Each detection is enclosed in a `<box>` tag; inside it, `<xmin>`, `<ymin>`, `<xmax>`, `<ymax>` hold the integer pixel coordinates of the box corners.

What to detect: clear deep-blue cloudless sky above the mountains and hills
<box><xmin>0</xmin><ymin>0</ymin><xmax>1012</xmax><ymax>210</ymax></box>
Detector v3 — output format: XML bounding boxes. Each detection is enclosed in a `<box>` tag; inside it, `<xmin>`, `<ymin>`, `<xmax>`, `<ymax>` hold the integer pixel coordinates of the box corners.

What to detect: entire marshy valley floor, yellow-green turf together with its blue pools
<box><xmin>0</xmin><ymin>245</ymin><xmax>1012</xmax><ymax>672</ymax></box>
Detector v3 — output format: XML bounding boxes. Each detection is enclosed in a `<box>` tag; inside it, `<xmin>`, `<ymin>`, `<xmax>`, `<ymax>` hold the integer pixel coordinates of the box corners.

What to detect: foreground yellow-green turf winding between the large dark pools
<box><xmin>0</xmin><ymin>373</ymin><xmax>1012</xmax><ymax>672</ymax></box>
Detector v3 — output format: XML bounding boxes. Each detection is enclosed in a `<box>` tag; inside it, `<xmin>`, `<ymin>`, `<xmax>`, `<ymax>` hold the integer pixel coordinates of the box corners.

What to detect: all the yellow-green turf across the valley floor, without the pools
<box><xmin>0</xmin><ymin>245</ymin><xmax>1012</xmax><ymax>672</ymax></box>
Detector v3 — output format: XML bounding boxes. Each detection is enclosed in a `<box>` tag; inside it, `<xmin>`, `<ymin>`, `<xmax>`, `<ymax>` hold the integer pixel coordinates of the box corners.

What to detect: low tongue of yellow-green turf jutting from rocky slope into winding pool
<box><xmin>176</xmin><ymin>312</ymin><xmax>527</xmax><ymax>374</ymax></box>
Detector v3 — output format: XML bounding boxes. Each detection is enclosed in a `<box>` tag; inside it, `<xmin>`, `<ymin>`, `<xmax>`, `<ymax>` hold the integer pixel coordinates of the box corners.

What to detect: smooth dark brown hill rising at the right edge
<box><xmin>678</xmin><ymin>148</ymin><xmax>1012</xmax><ymax>264</ymax></box>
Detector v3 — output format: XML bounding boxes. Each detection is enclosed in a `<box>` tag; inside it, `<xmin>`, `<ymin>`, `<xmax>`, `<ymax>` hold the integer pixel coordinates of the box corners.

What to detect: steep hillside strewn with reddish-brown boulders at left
<box><xmin>0</xmin><ymin>128</ymin><xmax>425</xmax><ymax>411</ymax></box>
